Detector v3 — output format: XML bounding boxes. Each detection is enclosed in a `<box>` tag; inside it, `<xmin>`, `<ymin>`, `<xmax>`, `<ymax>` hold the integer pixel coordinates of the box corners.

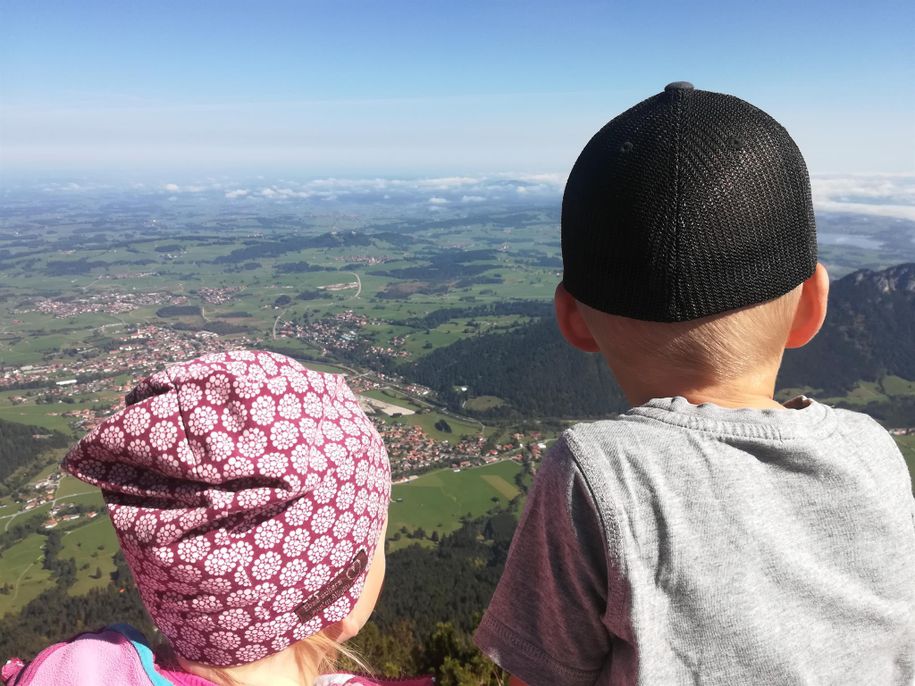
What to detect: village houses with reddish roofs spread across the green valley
<box><xmin>0</xmin><ymin>280</ymin><xmax>546</xmax><ymax>552</ymax></box>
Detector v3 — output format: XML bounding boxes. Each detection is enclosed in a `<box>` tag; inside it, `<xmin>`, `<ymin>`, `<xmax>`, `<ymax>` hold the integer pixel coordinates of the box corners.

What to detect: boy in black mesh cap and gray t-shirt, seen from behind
<box><xmin>476</xmin><ymin>82</ymin><xmax>915</xmax><ymax>686</ymax></box>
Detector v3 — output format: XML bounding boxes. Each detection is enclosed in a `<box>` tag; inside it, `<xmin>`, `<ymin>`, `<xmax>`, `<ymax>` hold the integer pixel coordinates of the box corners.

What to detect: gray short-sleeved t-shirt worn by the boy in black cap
<box><xmin>475</xmin><ymin>398</ymin><xmax>915</xmax><ymax>686</ymax></box>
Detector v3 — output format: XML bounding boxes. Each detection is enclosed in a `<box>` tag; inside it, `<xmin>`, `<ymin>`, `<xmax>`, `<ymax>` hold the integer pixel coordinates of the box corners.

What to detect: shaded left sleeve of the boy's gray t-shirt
<box><xmin>474</xmin><ymin>439</ymin><xmax>612</xmax><ymax>686</ymax></box>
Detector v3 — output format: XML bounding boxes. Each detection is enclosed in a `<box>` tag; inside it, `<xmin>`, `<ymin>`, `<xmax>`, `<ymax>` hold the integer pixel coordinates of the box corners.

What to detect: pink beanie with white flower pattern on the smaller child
<box><xmin>63</xmin><ymin>351</ymin><xmax>391</xmax><ymax>666</ymax></box>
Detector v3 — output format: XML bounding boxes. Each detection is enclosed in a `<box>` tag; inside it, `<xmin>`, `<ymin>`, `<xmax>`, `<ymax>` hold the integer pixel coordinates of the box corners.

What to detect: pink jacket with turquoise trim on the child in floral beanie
<box><xmin>0</xmin><ymin>624</ymin><xmax>435</xmax><ymax>686</ymax></box>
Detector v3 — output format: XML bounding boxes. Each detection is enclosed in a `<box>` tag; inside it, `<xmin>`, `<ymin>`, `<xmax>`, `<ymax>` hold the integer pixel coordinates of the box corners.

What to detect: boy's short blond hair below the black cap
<box><xmin>579</xmin><ymin>286</ymin><xmax>801</xmax><ymax>382</ymax></box>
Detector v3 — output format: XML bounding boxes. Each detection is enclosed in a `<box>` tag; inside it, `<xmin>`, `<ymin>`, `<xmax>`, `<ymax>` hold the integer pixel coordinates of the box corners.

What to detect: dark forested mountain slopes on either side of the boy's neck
<box><xmin>410</xmin><ymin>264</ymin><xmax>915</xmax><ymax>418</ymax></box>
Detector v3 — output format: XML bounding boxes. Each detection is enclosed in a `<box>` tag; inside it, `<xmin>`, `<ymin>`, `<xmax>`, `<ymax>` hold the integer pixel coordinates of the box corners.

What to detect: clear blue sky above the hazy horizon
<box><xmin>0</xmin><ymin>0</ymin><xmax>915</xmax><ymax>178</ymax></box>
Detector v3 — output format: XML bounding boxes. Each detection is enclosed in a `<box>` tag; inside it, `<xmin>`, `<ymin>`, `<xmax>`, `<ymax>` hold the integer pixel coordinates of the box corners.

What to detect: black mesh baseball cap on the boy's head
<box><xmin>562</xmin><ymin>81</ymin><xmax>817</xmax><ymax>322</ymax></box>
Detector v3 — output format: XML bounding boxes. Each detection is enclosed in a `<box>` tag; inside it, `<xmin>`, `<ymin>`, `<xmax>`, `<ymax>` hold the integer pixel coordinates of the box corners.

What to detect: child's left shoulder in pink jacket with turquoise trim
<box><xmin>3</xmin><ymin>624</ymin><xmax>172</xmax><ymax>686</ymax></box>
